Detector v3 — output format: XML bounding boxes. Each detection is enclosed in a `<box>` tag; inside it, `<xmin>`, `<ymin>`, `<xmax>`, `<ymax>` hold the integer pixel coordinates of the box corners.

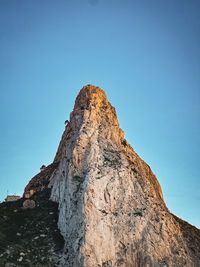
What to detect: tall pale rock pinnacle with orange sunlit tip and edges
<box><xmin>49</xmin><ymin>85</ymin><xmax>200</xmax><ymax>267</ymax></box>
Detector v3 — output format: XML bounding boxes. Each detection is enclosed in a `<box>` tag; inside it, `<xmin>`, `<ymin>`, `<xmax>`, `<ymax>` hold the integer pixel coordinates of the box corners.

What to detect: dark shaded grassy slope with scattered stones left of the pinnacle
<box><xmin>0</xmin><ymin>189</ymin><xmax>64</xmax><ymax>266</ymax></box>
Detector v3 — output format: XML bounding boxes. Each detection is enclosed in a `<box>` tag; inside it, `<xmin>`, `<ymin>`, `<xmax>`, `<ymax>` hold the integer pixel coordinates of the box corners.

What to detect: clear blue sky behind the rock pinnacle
<box><xmin>0</xmin><ymin>0</ymin><xmax>200</xmax><ymax>227</ymax></box>
